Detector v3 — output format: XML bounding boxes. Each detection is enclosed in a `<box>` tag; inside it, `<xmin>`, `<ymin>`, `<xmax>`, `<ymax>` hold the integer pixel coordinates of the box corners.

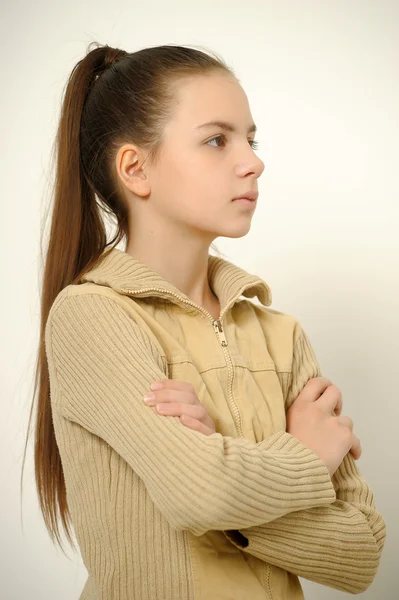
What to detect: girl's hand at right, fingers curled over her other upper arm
<box><xmin>286</xmin><ymin>377</ymin><xmax>362</xmax><ymax>476</ymax></box>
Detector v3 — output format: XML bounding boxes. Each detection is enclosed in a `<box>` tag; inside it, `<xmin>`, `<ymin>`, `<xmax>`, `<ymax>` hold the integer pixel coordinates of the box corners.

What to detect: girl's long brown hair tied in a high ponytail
<box><xmin>21</xmin><ymin>42</ymin><xmax>236</xmax><ymax>549</ymax></box>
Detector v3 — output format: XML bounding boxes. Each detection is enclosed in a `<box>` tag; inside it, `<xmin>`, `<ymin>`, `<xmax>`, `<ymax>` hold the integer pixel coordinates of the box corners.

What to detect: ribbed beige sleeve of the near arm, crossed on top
<box><xmin>45</xmin><ymin>288</ymin><xmax>336</xmax><ymax>535</ymax></box>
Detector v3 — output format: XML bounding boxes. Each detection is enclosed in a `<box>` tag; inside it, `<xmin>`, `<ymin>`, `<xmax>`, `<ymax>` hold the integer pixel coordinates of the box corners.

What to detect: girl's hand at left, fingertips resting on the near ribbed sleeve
<box><xmin>144</xmin><ymin>379</ymin><xmax>216</xmax><ymax>435</ymax></box>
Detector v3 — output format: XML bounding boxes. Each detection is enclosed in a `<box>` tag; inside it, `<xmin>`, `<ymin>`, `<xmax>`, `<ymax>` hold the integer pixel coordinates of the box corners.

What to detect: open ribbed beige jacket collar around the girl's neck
<box><xmin>78</xmin><ymin>248</ymin><xmax>272</xmax><ymax>316</ymax></box>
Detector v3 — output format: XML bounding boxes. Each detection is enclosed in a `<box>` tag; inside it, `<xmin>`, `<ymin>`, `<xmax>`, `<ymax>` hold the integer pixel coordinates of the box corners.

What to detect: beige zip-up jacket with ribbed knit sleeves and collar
<box><xmin>45</xmin><ymin>248</ymin><xmax>385</xmax><ymax>600</ymax></box>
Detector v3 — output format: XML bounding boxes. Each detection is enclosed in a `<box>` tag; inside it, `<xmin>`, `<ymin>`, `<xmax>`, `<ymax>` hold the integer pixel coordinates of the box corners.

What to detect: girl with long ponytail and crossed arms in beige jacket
<box><xmin>22</xmin><ymin>45</ymin><xmax>385</xmax><ymax>600</ymax></box>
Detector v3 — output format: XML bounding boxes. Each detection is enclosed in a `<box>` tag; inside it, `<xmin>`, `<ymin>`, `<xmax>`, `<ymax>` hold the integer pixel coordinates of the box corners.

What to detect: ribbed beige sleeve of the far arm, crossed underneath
<box><xmin>225</xmin><ymin>329</ymin><xmax>386</xmax><ymax>594</ymax></box>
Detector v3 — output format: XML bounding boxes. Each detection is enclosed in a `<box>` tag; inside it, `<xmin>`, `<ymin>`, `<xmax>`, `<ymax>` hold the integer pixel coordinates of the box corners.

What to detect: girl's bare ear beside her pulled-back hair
<box><xmin>115</xmin><ymin>144</ymin><xmax>151</xmax><ymax>196</ymax></box>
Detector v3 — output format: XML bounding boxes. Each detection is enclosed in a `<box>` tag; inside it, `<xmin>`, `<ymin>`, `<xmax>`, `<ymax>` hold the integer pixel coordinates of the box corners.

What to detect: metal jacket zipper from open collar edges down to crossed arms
<box><xmin>122</xmin><ymin>284</ymin><xmax>247</xmax><ymax>438</ymax></box>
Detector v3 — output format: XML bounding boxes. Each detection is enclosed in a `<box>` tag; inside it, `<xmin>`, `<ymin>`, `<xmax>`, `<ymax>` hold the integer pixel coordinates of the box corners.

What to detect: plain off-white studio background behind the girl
<box><xmin>0</xmin><ymin>0</ymin><xmax>399</xmax><ymax>600</ymax></box>
